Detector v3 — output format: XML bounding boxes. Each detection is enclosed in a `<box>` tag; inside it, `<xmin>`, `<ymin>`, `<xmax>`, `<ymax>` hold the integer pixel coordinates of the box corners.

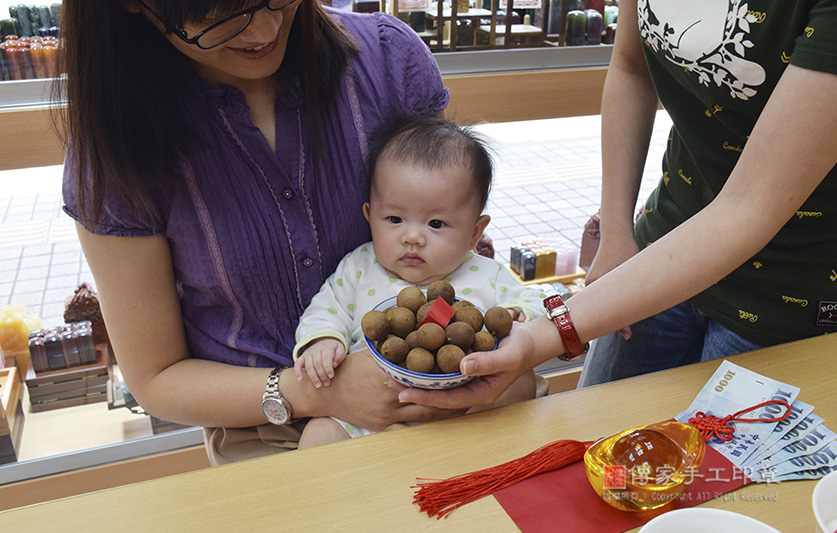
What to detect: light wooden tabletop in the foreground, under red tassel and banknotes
<box><xmin>0</xmin><ymin>335</ymin><xmax>837</xmax><ymax>533</ymax></box>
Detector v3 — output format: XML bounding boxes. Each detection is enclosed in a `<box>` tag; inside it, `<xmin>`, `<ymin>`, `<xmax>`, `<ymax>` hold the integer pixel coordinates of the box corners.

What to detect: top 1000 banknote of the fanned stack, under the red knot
<box><xmin>676</xmin><ymin>360</ymin><xmax>800</xmax><ymax>467</ymax></box>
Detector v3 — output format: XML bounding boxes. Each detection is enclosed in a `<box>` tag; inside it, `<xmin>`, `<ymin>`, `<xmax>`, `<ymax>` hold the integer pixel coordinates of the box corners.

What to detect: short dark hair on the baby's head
<box><xmin>369</xmin><ymin>115</ymin><xmax>494</xmax><ymax>212</ymax></box>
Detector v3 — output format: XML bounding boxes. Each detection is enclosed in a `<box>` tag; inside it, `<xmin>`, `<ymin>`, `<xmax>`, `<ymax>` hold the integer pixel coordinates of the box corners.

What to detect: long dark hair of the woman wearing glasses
<box><xmin>54</xmin><ymin>0</ymin><xmax>357</xmax><ymax>230</ymax></box>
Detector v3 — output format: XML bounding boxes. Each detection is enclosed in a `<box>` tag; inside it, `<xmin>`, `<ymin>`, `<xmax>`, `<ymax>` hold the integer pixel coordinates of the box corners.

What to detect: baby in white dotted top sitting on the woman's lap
<box><xmin>294</xmin><ymin>117</ymin><xmax>545</xmax><ymax>448</ymax></box>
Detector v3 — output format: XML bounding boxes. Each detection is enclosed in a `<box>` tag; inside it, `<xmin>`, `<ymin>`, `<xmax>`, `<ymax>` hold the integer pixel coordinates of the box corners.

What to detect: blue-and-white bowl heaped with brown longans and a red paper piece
<box><xmin>361</xmin><ymin>281</ymin><xmax>512</xmax><ymax>389</ymax></box>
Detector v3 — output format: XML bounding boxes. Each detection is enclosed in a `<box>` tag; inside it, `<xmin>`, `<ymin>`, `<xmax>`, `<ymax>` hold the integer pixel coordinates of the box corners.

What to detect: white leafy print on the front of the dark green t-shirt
<box><xmin>637</xmin><ymin>0</ymin><xmax>765</xmax><ymax>100</ymax></box>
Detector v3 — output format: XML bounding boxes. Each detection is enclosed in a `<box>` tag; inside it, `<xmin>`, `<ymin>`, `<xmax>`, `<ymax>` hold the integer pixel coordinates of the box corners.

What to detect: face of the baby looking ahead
<box><xmin>363</xmin><ymin>159</ymin><xmax>489</xmax><ymax>285</ymax></box>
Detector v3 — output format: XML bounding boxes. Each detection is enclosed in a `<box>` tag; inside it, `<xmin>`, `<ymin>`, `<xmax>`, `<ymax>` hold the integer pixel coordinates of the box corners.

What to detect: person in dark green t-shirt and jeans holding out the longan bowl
<box><xmin>400</xmin><ymin>0</ymin><xmax>837</xmax><ymax>408</ymax></box>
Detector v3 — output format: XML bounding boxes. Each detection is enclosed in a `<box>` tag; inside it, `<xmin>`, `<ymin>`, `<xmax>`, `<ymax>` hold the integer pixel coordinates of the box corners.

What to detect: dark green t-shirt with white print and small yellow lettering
<box><xmin>636</xmin><ymin>0</ymin><xmax>837</xmax><ymax>345</ymax></box>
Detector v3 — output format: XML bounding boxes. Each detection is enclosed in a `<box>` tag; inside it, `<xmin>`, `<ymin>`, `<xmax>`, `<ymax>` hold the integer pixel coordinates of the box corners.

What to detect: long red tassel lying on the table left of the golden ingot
<box><xmin>412</xmin><ymin>440</ymin><xmax>593</xmax><ymax>520</ymax></box>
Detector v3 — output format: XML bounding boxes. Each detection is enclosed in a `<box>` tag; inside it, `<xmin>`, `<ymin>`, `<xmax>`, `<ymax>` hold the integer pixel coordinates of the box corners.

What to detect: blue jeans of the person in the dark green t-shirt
<box><xmin>578</xmin><ymin>301</ymin><xmax>761</xmax><ymax>388</ymax></box>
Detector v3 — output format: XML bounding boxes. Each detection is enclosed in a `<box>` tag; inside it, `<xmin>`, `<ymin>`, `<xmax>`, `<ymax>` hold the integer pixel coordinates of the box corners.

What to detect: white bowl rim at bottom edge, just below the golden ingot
<box><xmin>639</xmin><ymin>507</ymin><xmax>780</xmax><ymax>533</ymax></box>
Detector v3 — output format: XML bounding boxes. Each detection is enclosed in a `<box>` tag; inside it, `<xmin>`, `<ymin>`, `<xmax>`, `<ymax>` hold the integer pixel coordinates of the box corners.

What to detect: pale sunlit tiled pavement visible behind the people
<box><xmin>0</xmin><ymin>112</ymin><xmax>670</xmax><ymax>326</ymax></box>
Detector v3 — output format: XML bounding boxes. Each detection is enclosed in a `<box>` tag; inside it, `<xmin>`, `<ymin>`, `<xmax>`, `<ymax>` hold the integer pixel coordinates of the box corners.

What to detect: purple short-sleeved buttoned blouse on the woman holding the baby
<box><xmin>64</xmin><ymin>11</ymin><xmax>448</xmax><ymax>367</ymax></box>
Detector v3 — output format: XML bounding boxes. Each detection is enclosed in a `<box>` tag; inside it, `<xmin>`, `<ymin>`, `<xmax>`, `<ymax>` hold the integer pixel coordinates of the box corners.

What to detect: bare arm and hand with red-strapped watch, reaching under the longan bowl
<box><xmin>400</xmin><ymin>65</ymin><xmax>837</xmax><ymax>407</ymax></box>
